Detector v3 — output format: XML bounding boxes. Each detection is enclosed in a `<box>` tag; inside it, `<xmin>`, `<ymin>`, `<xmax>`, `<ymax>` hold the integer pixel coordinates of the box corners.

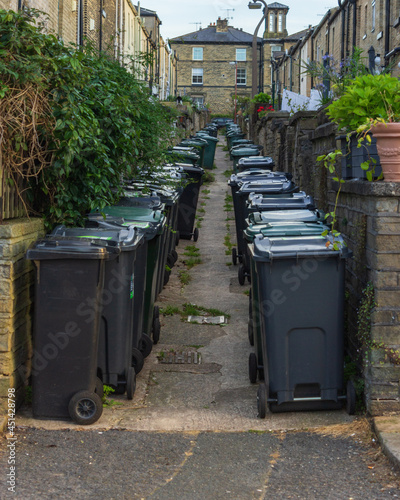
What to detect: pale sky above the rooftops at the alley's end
<box><xmin>140</xmin><ymin>0</ymin><xmax>338</xmax><ymax>39</ymax></box>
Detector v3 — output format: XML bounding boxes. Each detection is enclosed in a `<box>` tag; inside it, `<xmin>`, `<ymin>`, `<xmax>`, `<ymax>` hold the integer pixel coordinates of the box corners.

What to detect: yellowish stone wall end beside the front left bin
<box><xmin>0</xmin><ymin>218</ymin><xmax>44</xmax><ymax>431</ymax></box>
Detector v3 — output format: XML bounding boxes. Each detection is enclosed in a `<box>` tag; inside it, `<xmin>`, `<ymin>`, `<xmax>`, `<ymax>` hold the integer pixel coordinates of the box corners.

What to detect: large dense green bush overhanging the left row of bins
<box><xmin>0</xmin><ymin>10</ymin><xmax>174</xmax><ymax>226</ymax></box>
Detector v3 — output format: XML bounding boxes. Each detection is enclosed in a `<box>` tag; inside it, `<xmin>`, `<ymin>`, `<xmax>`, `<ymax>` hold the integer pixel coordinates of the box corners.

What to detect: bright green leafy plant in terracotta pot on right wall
<box><xmin>327</xmin><ymin>74</ymin><xmax>400</xmax><ymax>182</ymax></box>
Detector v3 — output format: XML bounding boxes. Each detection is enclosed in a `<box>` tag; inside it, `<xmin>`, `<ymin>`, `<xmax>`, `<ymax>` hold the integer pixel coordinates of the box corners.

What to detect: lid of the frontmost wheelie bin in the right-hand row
<box><xmin>253</xmin><ymin>233</ymin><xmax>352</xmax><ymax>262</ymax></box>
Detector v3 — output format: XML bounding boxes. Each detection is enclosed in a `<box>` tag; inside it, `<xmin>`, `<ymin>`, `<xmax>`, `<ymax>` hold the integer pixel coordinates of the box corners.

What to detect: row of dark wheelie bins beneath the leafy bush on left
<box><xmin>26</xmin><ymin>140</ymin><xmax>214</xmax><ymax>425</ymax></box>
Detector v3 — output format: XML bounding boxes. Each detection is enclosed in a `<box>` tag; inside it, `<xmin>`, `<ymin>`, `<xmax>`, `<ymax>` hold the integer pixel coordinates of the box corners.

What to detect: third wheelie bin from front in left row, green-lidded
<box><xmin>86</xmin><ymin>205</ymin><xmax>166</xmax><ymax>346</ymax></box>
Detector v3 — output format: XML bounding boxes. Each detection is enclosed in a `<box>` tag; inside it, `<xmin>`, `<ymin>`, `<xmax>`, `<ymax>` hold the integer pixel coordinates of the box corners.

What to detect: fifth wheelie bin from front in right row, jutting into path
<box><xmin>232</xmin><ymin>174</ymin><xmax>299</xmax><ymax>265</ymax></box>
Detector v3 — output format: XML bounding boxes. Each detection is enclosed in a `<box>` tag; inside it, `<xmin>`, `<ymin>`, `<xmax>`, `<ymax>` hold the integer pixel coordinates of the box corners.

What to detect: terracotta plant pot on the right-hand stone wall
<box><xmin>371</xmin><ymin>123</ymin><xmax>400</xmax><ymax>182</ymax></box>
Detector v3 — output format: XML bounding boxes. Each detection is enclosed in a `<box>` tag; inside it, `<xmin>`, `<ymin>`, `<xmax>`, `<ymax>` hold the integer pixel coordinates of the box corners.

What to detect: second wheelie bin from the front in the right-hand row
<box><xmin>244</xmin><ymin>220</ymin><xmax>330</xmax><ymax>384</ymax></box>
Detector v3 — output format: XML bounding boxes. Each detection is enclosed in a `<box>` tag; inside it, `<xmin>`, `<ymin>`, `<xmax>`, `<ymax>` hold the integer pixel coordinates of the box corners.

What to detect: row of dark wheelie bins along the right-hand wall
<box><xmin>228</xmin><ymin>126</ymin><xmax>355</xmax><ymax>418</ymax></box>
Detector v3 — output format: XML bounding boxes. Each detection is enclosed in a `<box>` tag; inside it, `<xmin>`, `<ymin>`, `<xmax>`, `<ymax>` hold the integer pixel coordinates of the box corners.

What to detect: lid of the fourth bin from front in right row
<box><xmin>247</xmin><ymin>191</ymin><xmax>315</xmax><ymax>212</ymax></box>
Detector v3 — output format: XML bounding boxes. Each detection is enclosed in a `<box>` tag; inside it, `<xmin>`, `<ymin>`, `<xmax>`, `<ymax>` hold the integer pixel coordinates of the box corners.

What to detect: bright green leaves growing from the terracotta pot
<box><xmin>327</xmin><ymin>74</ymin><xmax>400</xmax><ymax>132</ymax></box>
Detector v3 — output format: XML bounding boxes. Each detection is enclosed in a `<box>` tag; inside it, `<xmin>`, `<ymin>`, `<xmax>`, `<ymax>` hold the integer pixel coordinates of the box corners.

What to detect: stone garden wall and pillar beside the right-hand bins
<box><xmin>252</xmin><ymin>112</ymin><xmax>400</xmax><ymax>415</ymax></box>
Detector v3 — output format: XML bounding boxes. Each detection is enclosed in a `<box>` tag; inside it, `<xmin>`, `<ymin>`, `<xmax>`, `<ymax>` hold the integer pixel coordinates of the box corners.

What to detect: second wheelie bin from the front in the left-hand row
<box><xmin>52</xmin><ymin>226</ymin><xmax>146</xmax><ymax>399</ymax></box>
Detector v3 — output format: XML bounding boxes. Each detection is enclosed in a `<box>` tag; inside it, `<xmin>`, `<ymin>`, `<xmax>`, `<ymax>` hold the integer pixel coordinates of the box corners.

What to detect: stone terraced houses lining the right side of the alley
<box><xmin>274</xmin><ymin>0</ymin><xmax>400</xmax><ymax>101</ymax></box>
